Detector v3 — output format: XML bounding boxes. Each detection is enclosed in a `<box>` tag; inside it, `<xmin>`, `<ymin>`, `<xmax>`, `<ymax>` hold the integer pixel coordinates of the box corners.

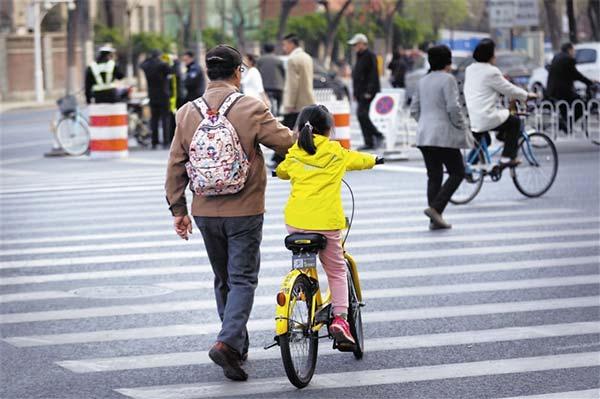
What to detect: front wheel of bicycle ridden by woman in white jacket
<box><xmin>511</xmin><ymin>132</ymin><xmax>558</xmax><ymax>198</ymax></box>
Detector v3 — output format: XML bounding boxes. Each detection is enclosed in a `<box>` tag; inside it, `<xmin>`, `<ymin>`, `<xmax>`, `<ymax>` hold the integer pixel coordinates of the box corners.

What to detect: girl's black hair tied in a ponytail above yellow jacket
<box><xmin>296</xmin><ymin>104</ymin><xmax>333</xmax><ymax>155</ymax></box>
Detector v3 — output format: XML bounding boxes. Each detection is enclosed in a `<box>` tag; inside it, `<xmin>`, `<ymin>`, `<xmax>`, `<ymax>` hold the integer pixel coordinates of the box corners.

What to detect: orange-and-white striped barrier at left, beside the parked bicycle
<box><xmin>89</xmin><ymin>103</ymin><xmax>129</xmax><ymax>158</ymax></box>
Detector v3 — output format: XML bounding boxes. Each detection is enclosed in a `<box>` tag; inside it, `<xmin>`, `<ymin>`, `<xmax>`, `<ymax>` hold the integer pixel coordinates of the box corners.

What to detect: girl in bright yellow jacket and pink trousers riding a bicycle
<box><xmin>276</xmin><ymin>105</ymin><xmax>376</xmax><ymax>343</ymax></box>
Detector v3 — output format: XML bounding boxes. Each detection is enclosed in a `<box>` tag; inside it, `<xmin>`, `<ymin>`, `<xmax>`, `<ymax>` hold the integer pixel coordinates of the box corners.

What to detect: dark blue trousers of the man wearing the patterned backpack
<box><xmin>194</xmin><ymin>215</ymin><xmax>263</xmax><ymax>355</ymax></box>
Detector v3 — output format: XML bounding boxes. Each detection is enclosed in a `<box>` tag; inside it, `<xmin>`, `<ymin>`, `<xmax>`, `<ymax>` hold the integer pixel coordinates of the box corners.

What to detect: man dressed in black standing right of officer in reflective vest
<box><xmin>140</xmin><ymin>50</ymin><xmax>172</xmax><ymax>149</ymax></box>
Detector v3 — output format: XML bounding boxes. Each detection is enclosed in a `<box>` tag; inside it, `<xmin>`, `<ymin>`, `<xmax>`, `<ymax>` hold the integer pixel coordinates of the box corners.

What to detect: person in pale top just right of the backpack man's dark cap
<box><xmin>256</xmin><ymin>43</ymin><xmax>285</xmax><ymax>116</ymax></box>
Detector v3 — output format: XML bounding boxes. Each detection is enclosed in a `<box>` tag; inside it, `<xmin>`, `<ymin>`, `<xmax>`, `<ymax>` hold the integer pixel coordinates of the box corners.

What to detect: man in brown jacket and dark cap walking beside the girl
<box><xmin>165</xmin><ymin>45</ymin><xmax>294</xmax><ymax>381</ymax></box>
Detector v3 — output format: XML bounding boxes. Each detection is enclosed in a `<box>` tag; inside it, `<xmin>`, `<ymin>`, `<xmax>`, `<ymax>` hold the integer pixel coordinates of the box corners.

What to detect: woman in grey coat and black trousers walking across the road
<box><xmin>410</xmin><ymin>46</ymin><xmax>473</xmax><ymax>230</ymax></box>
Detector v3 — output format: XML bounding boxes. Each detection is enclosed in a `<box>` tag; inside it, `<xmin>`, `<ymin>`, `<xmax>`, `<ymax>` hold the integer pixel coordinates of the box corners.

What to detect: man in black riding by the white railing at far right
<box><xmin>546</xmin><ymin>43</ymin><xmax>593</xmax><ymax>130</ymax></box>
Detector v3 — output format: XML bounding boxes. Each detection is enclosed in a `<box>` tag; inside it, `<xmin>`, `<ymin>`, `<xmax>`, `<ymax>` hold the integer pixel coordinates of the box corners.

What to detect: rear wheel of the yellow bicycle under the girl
<box><xmin>279</xmin><ymin>276</ymin><xmax>319</xmax><ymax>388</ymax></box>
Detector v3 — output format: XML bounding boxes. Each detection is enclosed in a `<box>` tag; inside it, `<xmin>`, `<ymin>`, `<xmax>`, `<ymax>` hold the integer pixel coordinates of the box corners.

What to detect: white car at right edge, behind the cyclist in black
<box><xmin>527</xmin><ymin>42</ymin><xmax>600</xmax><ymax>101</ymax></box>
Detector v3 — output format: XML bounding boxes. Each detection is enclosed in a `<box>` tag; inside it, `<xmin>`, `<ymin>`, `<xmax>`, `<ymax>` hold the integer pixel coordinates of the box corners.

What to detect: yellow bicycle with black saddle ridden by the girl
<box><xmin>265</xmin><ymin>181</ymin><xmax>365</xmax><ymax>388</ymax></box>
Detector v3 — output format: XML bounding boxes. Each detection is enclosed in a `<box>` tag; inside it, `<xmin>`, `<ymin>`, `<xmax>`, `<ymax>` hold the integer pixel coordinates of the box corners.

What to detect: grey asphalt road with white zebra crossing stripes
<box><xmin>0</xmin><ymin>107</ymin><xmax>600</xmax><ymax>399</ymax></box>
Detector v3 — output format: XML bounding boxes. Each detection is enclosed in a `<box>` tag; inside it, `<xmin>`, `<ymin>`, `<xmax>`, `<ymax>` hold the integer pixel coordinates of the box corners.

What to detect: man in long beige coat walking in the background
<box><xmin>271</xmin><ymin>33</ymin><xmax>315</xmax><ymax>168</ymax></box>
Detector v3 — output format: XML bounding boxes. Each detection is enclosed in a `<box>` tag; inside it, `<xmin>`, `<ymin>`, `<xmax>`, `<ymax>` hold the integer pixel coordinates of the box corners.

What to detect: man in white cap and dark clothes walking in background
<box><xmin>348</xmin><ymin>33</ymin><xmax>383</xmax><ymax>150</ymax></box>
